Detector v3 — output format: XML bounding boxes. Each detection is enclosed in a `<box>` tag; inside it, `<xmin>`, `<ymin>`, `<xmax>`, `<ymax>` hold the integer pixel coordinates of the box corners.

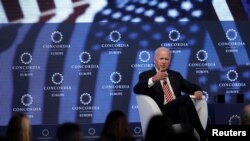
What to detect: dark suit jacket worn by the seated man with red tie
<box><xmin>134</xmin><ymin>68</ymin><xmax>202</xmax><ymax>107</ymax></box>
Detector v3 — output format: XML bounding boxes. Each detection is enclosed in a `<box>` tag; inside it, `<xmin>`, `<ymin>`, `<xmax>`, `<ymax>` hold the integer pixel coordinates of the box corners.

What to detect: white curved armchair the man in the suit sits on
<box><xmin>136</xmin><ymin>95</ymin><xmax>208</xmax><ymax>137</ymax></box>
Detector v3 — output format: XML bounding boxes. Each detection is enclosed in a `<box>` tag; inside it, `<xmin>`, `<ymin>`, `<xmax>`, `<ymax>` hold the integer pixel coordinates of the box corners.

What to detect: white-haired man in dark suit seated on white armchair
<box><xmin>134</xmin><ymin>47</ymin><xmax>206</xmax><ymax>140</ymax></box>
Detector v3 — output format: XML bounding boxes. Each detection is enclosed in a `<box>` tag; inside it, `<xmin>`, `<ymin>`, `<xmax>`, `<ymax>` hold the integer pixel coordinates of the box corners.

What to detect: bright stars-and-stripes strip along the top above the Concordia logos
<box><xmin>0</xmin><ymin>0</ymin><xmax>250</xmax><ymax>23</ymax></box>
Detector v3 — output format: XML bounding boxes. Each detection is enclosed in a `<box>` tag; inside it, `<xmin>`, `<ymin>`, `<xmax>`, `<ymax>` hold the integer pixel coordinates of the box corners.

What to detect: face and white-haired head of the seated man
<box><xmin>154</xmin><ymin>50</ymin><xmax>171</xmax><ymax>71</ymax></box>
